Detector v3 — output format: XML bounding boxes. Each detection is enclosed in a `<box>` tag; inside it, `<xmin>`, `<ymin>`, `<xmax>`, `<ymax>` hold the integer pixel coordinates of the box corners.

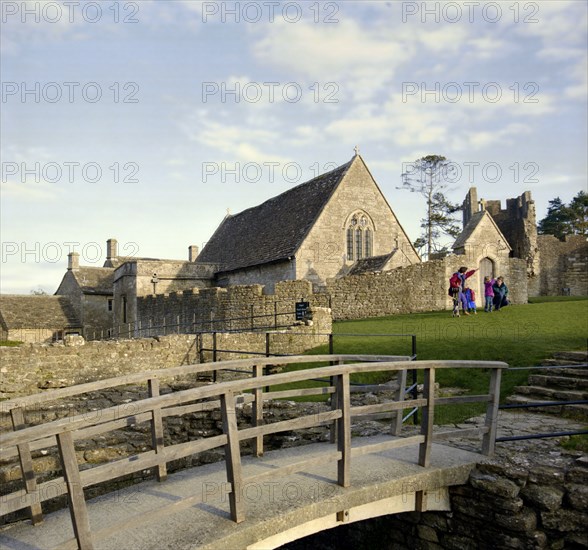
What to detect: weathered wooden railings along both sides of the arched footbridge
<box><xmin>0</xmin><ymin>355</ymin><xmax>508</xmax><ymax>550</ymax></box>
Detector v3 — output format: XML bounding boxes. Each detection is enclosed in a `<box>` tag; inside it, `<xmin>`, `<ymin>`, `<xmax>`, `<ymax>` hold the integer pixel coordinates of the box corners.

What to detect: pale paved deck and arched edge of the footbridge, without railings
<box><xmin>0</xmin><ymin>436</ymin><xmax>483</xmax><ymax>550</ymax></box>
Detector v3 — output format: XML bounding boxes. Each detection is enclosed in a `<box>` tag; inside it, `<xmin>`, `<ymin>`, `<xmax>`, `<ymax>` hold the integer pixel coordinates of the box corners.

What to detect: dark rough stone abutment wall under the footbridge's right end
<box><xmin>389</xmin><ymin>457</ymin><xmax>588</xmax><ymax>548</ymax></box>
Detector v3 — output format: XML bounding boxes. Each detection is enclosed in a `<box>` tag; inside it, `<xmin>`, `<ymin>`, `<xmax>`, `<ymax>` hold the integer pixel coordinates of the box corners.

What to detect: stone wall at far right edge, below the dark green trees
<box><xmin>529</xmin><ymin>235</ymin><xmax>588</xmax><ymax>296</ymax></box>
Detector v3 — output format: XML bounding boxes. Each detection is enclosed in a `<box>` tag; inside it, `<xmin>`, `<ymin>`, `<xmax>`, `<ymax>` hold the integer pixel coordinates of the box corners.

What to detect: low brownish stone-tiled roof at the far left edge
<box><xmin>0</xmin><ymin>294</ymin><xmax>82</xmax><ymax>330</ymax></box>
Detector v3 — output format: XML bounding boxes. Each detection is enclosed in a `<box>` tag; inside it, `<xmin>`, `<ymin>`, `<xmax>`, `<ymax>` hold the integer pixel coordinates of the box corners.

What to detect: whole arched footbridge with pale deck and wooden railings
<box><xmin>0</xmin><ymin>355</ymin><xmax>507</xmax><ymax>550</ymax></box>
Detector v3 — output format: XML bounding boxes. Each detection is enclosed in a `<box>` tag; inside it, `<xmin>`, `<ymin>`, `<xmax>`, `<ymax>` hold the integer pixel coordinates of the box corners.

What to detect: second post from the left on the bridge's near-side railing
<box><xmin>221</xmin><ymin>391</ymin><xmax>245</xmax><ymax>523</ymax></box>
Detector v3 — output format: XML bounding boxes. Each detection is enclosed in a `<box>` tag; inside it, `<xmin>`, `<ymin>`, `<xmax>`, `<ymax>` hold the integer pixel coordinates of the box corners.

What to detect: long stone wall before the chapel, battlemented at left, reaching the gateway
<box><xmin>129</xmin><ymin>255</ymin><xmax>528</xmax><ymax>328</ymax></box>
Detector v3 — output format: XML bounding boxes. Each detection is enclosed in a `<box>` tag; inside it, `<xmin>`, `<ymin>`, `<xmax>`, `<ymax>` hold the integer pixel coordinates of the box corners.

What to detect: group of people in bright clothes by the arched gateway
<box><xmin>449</xmin><ymin>266</ymin><xmax>509</xmax><ymax>317</ymax></box>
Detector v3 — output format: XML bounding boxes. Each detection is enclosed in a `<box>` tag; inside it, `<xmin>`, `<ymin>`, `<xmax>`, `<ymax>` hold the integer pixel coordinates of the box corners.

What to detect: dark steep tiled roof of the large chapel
<box><xmin>197</xmin><ymin>156</ymin><xmax>359</xmax><ymax>271</ymax></box>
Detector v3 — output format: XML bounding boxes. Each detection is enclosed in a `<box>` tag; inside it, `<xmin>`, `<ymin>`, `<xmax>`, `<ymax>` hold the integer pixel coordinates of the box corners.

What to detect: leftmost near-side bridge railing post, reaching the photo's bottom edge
<box><xmin>57</xmin><ymin>432</ymin><xmax>94</xmax><ymax>550</ymax></box>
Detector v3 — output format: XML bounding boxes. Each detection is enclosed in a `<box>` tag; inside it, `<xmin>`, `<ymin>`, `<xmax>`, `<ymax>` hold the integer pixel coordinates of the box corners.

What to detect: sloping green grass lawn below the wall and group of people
<box><xmin>268</xmin><ymin>302</ymin><xmax>588</xmax><ymax>421</ymax></box>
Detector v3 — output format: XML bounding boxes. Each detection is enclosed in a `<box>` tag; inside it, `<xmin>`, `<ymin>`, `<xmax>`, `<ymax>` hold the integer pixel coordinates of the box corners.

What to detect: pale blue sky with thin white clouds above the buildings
<box><xmin>0</xmin><ymin>0</ymin><xmax>588</xmax><ymax>294</ymax></box>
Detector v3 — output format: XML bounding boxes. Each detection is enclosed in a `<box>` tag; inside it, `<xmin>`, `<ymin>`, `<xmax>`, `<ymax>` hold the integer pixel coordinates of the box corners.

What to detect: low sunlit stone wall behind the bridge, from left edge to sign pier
<box><xmin>0</xmin><ymin>308</ymin><xmax>331</xmax><ymax>399</ymax></box>
